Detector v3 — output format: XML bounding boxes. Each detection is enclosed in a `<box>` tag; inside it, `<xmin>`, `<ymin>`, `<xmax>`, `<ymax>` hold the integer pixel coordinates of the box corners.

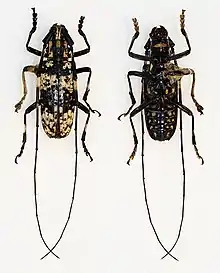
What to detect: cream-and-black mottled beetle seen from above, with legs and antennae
<box><xmin>15</xmin><ymin>8</ymin><xmax>101</xmax><ymax>259</ymax></box>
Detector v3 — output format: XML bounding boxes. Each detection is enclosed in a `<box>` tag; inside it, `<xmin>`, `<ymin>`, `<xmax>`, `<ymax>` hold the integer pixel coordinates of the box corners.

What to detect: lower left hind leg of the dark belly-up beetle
<box><xmin>127</xmin><ymin>99</ymin><xmax>156</xmax><ymax>165</ymax></box>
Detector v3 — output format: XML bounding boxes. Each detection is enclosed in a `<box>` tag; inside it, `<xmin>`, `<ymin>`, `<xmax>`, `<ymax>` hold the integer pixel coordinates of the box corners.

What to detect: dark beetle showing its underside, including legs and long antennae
<box><xmin>118</xmin><ymin>10</ymin><xmax>204</xmax><ymax>261</ymax></box>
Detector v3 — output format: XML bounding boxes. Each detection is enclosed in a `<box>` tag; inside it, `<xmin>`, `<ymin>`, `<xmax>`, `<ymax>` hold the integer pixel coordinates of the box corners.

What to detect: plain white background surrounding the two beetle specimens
<box><xmin>0</xmin><ymin>0</ymin><xmax>217</xmax><ymax>273</ymax></box>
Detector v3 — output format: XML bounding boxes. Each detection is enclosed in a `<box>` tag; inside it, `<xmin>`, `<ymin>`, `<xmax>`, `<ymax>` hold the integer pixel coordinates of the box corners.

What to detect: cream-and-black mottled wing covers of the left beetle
<box><xmin>40</xmin><ymin>73</ymin><xmax>77</xmax><ymax>138</ymax></box>
